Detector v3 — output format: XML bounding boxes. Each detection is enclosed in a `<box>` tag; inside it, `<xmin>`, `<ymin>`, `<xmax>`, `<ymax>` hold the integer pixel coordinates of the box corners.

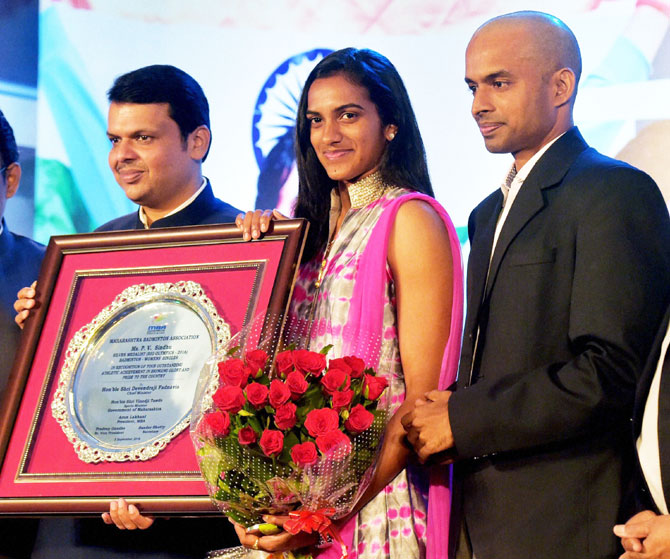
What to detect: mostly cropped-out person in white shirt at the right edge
<box><xmin>614</xmin><ymin>309</ymin><xmax>670</xmax><ymax>559</ymax></box>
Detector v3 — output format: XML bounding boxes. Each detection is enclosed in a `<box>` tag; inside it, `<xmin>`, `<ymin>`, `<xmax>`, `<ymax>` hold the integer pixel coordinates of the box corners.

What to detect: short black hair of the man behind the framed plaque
<box><xmin>107</xmin><ymin>64</ymin><xmax>211</xmax><ymax>161</ymax></box>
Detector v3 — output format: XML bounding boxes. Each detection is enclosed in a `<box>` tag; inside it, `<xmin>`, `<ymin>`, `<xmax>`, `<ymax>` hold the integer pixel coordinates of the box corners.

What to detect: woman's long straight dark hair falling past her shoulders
<box><xmin>295</xmin><ymin>48</ymin><xmax>434</xmax><ymax>262</ymax></box>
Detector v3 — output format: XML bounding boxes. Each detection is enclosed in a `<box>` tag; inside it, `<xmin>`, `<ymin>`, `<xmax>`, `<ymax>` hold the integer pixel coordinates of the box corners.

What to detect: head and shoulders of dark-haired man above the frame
<box><xmin>97</xmin><ymin>65</ymin><xmax>240</xmax><ymax>231</ymax></box>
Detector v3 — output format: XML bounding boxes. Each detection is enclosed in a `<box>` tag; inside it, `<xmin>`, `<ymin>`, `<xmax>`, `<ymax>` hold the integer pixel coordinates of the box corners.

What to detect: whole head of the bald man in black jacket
<box><xmin>465</xmin><ymin>12</ymin><xmax>582</xmax><ymax>169</ymax></box>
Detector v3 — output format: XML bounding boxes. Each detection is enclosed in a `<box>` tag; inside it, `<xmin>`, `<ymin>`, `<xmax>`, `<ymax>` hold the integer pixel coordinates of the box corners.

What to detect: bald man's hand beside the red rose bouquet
<box><xmin>401</xmin><ymin>390</ymin><xmax>454</xmax><ymax>464</ymax></box>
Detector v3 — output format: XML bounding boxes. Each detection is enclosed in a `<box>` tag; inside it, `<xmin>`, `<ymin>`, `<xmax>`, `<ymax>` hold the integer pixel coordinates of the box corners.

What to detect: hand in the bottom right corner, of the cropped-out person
<box><xmin>614</xmin><ymin>510</ymin><xmax>670</xmax><ymax>559</ymax></box>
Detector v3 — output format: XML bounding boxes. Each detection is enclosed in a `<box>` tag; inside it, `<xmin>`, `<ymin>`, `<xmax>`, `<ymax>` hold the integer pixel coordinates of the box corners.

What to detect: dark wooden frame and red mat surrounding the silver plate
<box><xmin>0</xmin><ymin>220</ymin><xmax>307</xmax><ymax>516</ymax></box>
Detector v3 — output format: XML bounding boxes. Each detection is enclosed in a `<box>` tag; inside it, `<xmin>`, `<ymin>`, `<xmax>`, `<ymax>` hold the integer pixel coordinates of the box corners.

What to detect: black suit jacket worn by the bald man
<box><xmin>449</xmin><ymin>128</ymin><xmax>670</xmax><ymax>559</ymax></box>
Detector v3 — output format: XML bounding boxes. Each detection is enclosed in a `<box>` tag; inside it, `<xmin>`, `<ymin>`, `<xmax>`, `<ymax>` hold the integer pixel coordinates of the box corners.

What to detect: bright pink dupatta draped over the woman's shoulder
<box><xmin>318</xmin><ymin>193</ymin><xmax>463</xmax><ymax>559</ymax></box>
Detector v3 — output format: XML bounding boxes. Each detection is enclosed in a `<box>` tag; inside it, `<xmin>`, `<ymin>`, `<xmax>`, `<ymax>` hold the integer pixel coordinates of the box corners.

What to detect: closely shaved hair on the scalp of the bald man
<box><xmin>472</xmin><ymin>11</ymin><xmax>582</xmax><ymax>91</ymax></box>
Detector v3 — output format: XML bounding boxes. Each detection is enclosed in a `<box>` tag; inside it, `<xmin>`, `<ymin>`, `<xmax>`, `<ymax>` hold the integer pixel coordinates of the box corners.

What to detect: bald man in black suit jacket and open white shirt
<box><xmin>403</xmin><ymin>12</ymin><xmax>670</xmax><ymax>559</ymax></box>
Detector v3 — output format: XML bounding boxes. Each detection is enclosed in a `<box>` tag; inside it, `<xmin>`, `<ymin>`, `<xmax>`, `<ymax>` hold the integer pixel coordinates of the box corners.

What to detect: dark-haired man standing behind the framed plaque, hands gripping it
<box><xmin>14</xmin><ymin>65</ymin><xmax>240</xmax><ymax>559</ymax></box>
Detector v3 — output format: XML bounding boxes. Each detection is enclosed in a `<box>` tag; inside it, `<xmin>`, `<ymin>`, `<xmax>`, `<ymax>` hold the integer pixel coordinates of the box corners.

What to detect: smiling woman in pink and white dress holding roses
<box><xmin>237</xmin><ymin>49</ymin><xmax>463</xmax><ymax>559</ymax></box>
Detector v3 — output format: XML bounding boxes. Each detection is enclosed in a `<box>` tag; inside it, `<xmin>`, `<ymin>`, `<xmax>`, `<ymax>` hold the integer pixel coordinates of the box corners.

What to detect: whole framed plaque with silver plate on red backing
<box><xmin>0</xmin><ymin>220</ymin><xmax>307</xmax><ymax>515</ymax></box>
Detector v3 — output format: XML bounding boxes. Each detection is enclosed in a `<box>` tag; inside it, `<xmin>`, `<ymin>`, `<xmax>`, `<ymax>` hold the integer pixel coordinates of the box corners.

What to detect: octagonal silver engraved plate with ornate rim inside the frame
<box><xmin>51</xmin><ymin>281</ymin><xmax>230</xmax><ymax>463</ymax></box>
